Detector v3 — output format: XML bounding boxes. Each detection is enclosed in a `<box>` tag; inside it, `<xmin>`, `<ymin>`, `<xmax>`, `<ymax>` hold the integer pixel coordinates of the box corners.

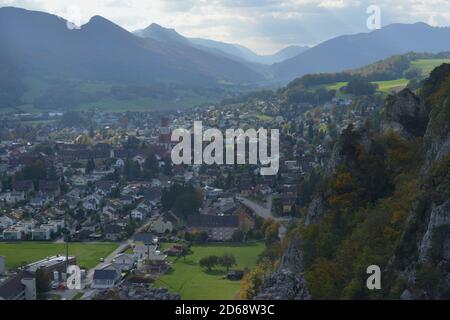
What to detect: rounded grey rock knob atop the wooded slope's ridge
<box><xmin>381</xmin><ymin>89</ymin><xmax>428</xmax><ymax>139</ymax></box>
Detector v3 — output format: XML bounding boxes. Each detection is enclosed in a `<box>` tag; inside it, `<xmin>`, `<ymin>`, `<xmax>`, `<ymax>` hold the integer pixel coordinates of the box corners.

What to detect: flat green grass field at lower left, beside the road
<box><xmin>0</xmin><ymin>242</ymin><xmax>118</xmax><ymax>269</ymax></box>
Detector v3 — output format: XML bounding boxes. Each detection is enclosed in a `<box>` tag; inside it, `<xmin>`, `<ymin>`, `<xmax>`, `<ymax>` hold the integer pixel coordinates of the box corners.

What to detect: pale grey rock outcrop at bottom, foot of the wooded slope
<box><xmin>255</xmin><ymin>237</ymin><xmax>311</xmax><ymax>300</ymax></box>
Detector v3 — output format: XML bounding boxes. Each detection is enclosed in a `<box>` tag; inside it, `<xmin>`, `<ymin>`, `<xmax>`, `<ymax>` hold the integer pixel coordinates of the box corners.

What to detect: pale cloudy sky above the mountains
<box><xmin>0</xmin><ymin>0</ymin><xmax>450</xmax><ymax>54</ymax></box>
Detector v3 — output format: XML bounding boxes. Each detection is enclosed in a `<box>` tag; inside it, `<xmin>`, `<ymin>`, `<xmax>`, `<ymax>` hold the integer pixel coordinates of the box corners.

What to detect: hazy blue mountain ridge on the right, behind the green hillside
<box><xmin>271</xmin><ymin>22</ymin><xmax>450</xmax><ymax>81</ymax></box>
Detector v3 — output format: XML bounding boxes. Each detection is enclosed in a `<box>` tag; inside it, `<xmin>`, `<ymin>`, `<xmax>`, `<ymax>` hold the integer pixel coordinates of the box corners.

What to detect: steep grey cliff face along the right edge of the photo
<box><xmin>389</xmin><ymin>65</ymin><xmax>450</xmax><ymax>299</ymax></box>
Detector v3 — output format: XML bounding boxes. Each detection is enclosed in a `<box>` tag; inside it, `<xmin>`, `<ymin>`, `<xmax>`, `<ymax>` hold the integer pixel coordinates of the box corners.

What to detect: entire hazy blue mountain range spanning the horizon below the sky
<box><xmin>0</xmin><ymin>7</ymin><xmax>450</xmax><ymax>86</ymax></box>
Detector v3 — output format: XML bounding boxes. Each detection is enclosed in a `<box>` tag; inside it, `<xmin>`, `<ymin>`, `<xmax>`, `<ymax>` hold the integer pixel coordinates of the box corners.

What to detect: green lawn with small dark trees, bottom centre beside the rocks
<box><xmin>155</xmin><ymin>242</ymin><xmax>264</xmax><ymax>300</ymax></box>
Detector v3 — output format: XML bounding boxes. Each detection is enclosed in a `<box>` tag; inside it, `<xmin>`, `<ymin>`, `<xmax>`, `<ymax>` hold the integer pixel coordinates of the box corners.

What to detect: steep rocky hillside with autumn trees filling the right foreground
<box><xmin>248</xmin><ymin>64</ymin><xmax>450</xmax><ymax>299</ymax></box>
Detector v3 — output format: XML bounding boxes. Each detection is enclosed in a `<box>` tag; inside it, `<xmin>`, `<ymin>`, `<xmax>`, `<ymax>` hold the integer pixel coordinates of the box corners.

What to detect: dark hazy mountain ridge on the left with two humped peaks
<box><xmin>0</xmin><ymin>7</ymin><xmax>263</xmax><ymax>85</ymax></box>
